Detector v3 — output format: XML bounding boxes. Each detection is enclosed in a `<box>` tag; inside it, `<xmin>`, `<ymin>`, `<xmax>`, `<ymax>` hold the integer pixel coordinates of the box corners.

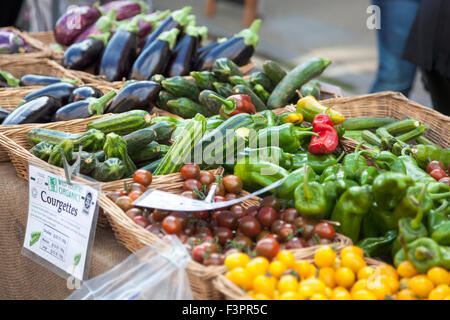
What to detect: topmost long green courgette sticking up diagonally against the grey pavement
<box><xmin>267</xmin><ymin>58</ymin><xmax>331</xmax><ymax>109</ymax></box>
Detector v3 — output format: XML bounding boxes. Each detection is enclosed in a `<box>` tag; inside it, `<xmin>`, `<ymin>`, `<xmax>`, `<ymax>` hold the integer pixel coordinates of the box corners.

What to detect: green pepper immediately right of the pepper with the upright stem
<box><xmin>331</xmin><ymin>185</ymin><xmax>373</xmax><ymax>242</ymax></box>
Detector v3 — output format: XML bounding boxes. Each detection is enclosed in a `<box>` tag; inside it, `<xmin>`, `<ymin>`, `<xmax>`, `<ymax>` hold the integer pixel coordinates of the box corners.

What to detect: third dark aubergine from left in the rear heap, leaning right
<box><xmin>131</xmin><ymin>28</ymin><xmax>180</xmax><ymax>80</ymax></box>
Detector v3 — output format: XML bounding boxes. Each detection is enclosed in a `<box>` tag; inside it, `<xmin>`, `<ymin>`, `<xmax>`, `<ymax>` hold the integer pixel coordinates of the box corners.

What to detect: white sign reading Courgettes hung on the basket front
<box><xmin>23</xmin><ymin>163</ymin><xmax>99</xmax><ymax>280</ymax></box>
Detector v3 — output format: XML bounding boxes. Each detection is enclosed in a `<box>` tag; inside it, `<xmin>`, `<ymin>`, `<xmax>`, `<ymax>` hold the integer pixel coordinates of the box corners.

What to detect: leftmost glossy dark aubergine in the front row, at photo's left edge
<box><xmin>2</xmin><ymin>96</ymin><xmax>61</xmax><ymax>125</ymax></box>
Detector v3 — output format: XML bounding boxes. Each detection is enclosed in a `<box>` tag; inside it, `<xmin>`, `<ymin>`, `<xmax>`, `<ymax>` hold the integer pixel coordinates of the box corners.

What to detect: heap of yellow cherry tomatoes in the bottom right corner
<box><xmin>225</xmin><ymin>246</ymin><xmax>450</xmax><ymax>300</ymax></box>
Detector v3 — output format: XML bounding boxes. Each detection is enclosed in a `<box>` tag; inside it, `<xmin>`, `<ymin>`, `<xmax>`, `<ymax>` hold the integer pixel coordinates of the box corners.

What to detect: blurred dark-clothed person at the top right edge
<box><xmin>404</xmin><ymin>0</ymin><xmax>450</xmax><ymax>115</ymax></box>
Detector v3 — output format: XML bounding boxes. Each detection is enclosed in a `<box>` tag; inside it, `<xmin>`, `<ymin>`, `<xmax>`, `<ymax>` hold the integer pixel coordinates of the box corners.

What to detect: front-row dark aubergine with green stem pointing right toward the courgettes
<box><xmin>52</xmin><ymin>91</ymin><xmax>117</xmax><ymax>121</ymax></box>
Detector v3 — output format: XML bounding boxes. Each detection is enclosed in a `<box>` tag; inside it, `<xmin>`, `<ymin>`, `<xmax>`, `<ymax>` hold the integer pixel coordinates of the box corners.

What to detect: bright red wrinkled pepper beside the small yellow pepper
<box><xmin>308</xmin><ymin>114</ymin><xmax>339</xmax><ymax>155</ymax></box>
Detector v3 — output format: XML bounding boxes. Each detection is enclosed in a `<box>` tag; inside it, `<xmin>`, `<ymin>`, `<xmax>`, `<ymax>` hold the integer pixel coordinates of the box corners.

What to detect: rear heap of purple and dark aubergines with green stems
<box><xmin>60</xmin><ymin>1</ymin><xmax>261</xmax><ymax>81</ymax></box>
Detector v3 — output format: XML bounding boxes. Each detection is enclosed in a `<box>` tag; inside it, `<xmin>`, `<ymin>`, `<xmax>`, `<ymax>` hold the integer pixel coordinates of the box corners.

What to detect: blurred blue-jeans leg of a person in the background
<box><xmin>370</xmin><ymin>0</ymin><xmax>422</xmax><ymax>96</ymax></box>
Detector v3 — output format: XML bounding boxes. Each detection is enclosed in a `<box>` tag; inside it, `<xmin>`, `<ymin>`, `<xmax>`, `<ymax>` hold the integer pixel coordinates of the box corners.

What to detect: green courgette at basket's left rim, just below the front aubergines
<box><xmin>87</xmin><ymin>110</ymin><xmax>151</xmax><ymax>135</ymax></box>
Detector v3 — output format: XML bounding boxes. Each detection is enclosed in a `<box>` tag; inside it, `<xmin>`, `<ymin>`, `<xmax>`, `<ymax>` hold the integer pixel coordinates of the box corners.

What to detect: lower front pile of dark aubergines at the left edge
<box><xmin>0</xmin><ymin>81</ymin><xmax>161</xmax><ymax>125</ymax></box>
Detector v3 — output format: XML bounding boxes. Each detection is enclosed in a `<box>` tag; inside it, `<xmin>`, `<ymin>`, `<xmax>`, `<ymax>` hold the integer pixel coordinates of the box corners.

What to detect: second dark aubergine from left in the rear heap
<box><xmin>100</xmin><ymin>19</ymin><xmax>138</xmax><ymax>81</ymax></box>
